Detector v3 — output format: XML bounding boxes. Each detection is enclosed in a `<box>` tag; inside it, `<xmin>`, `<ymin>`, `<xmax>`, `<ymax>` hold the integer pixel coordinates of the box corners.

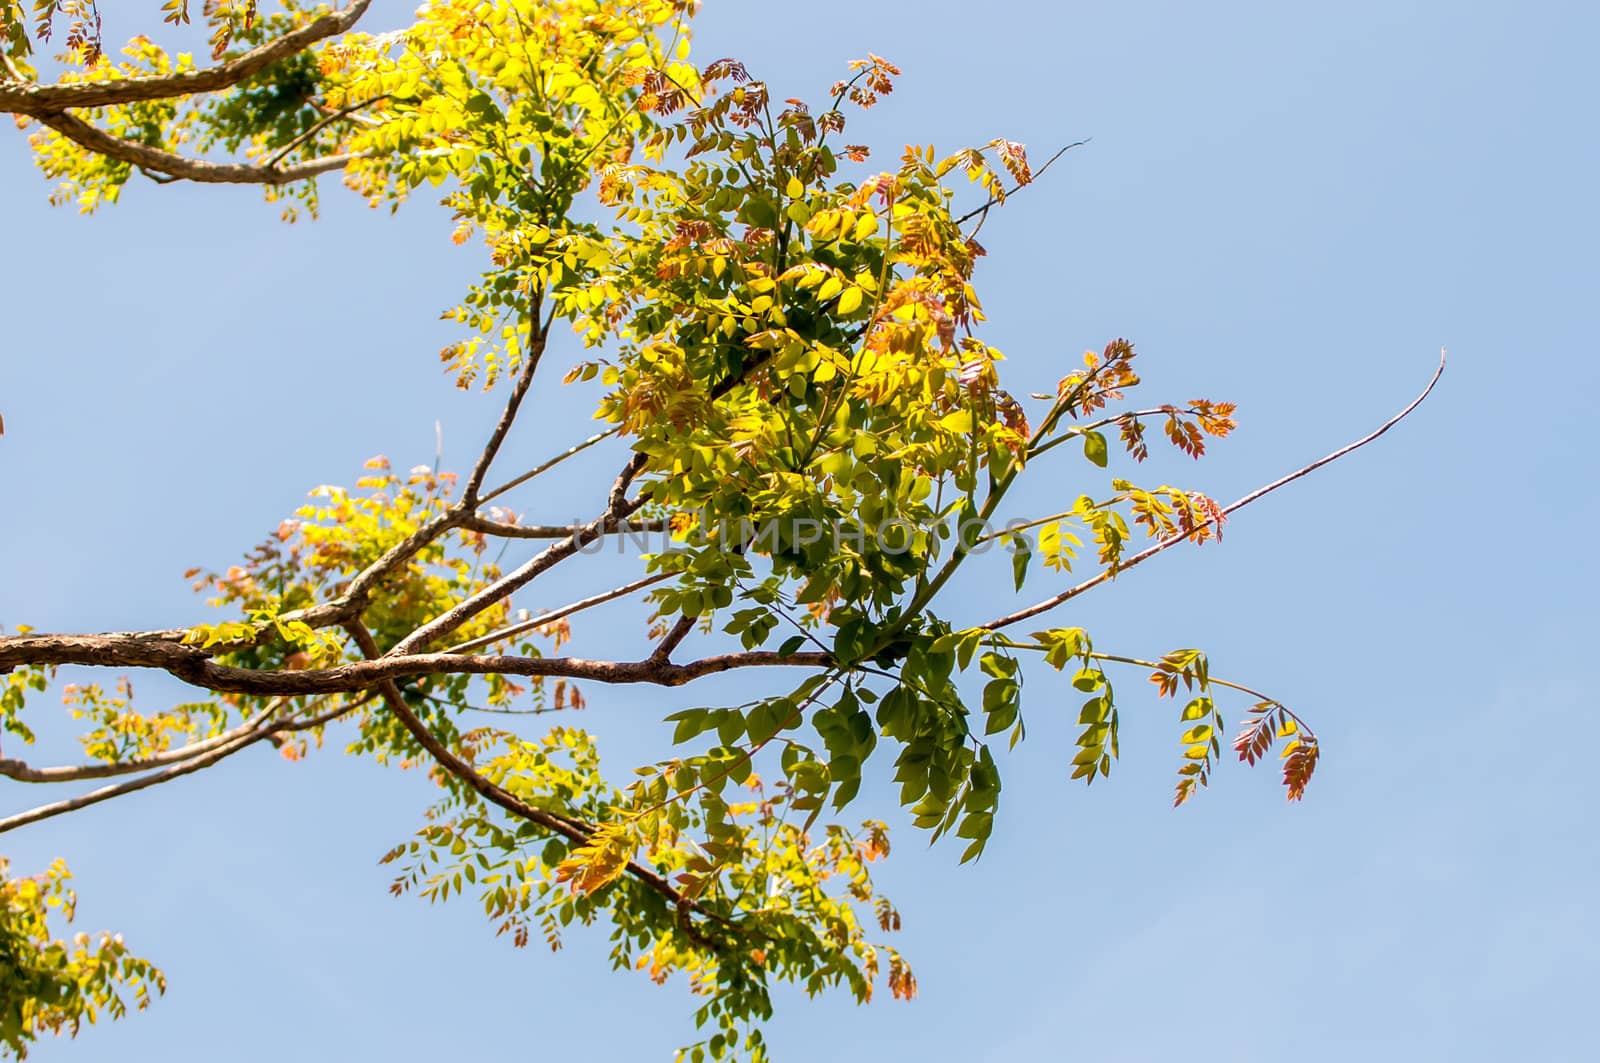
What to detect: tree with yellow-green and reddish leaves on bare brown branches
<box><xmin>0</xmin><ymin>0</ymin><xmax>1442</xmax><ymax>1060</ymax></box>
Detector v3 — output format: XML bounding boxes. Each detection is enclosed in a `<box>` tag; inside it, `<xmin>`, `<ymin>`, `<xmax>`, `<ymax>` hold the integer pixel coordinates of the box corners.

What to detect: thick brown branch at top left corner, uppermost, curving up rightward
<box><xmin>0</xmin><ymin>0</ymin><xmax>371</xmax><ymax>118</ymax></box>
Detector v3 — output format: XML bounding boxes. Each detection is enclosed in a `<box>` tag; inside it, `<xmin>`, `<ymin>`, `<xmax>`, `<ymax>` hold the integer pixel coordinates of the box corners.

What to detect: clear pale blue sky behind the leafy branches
<box><xmin>0</xmin><ymin>0</ymin><xmax>1600</xmax><ymax>1063</ymax></box>
